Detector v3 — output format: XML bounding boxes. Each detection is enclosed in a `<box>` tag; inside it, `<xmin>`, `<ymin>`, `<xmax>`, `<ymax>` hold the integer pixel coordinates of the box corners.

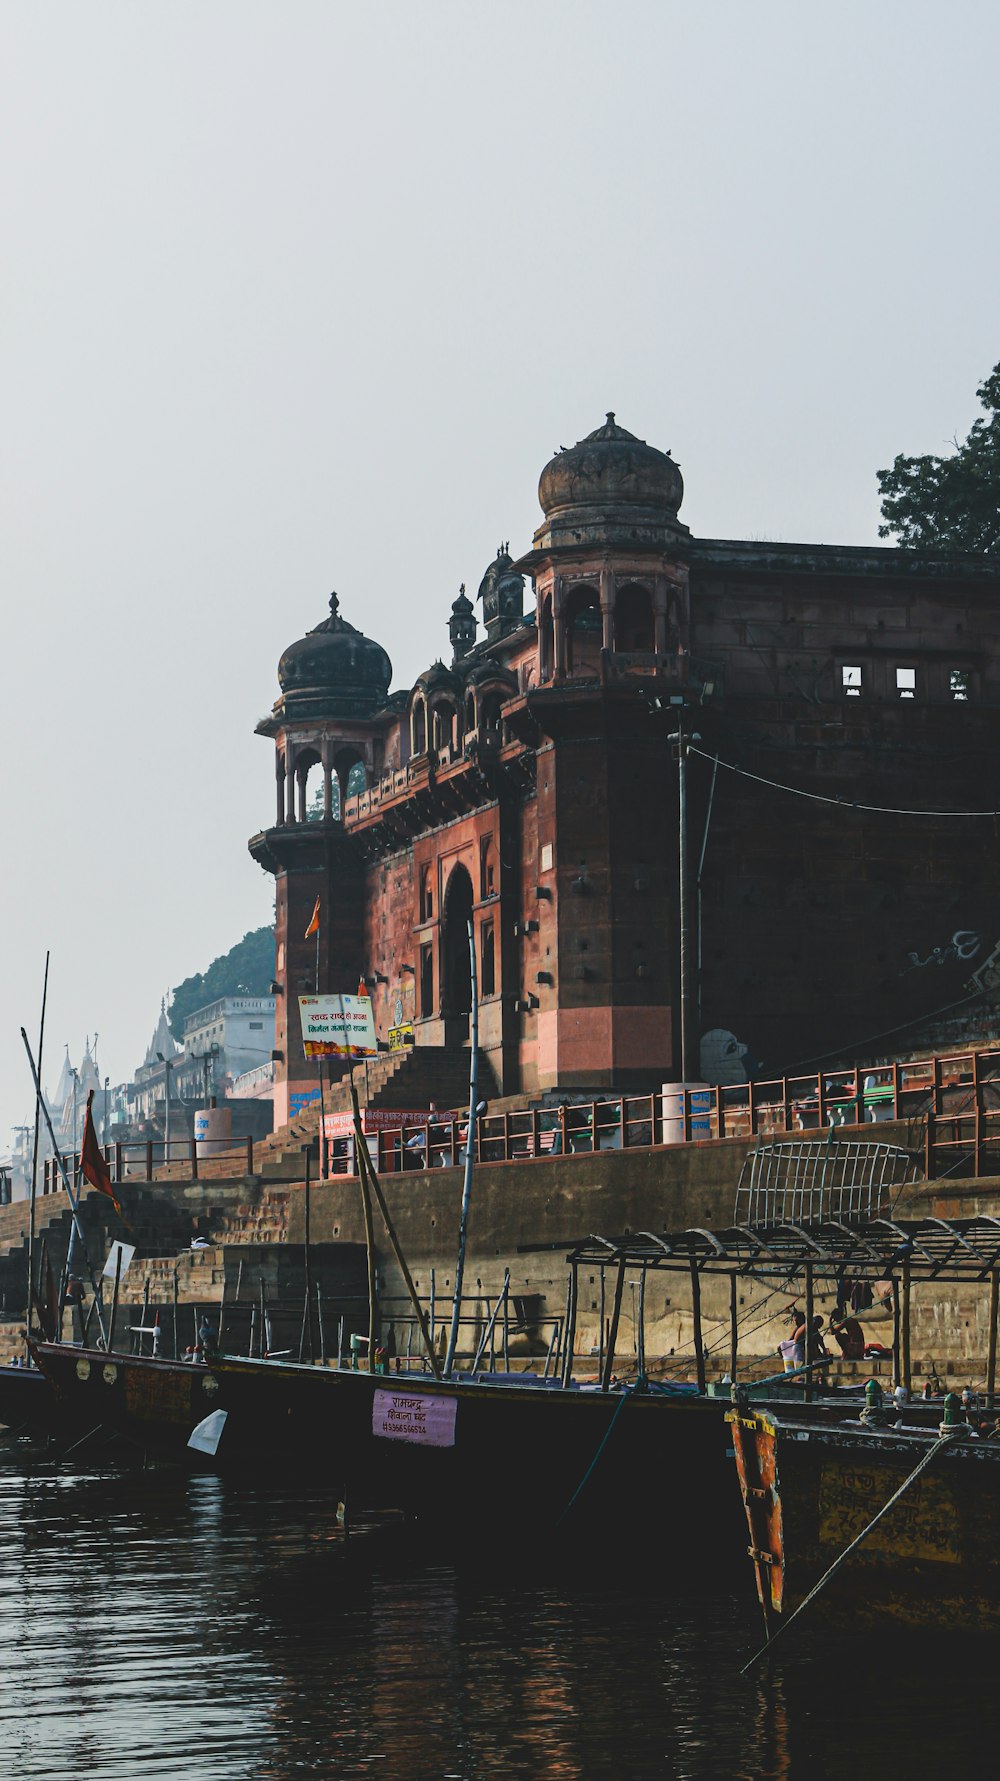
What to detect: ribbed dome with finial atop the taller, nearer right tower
<box><xmin>538</xmin><ymin>413</ymin><xmax>684</xmax><ymax>516</ymax></box>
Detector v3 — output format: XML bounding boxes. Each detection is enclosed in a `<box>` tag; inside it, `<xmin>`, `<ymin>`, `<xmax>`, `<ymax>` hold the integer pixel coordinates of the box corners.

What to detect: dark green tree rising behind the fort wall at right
<box><xmin>879</xmin><ymin>365</ymin><xmax>1000</xmax><ymax>556</ymax></box>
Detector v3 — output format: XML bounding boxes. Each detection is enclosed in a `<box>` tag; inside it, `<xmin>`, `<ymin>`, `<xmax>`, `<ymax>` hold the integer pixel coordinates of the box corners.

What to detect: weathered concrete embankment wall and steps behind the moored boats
<box><xmin>0</xmin><ymin>1126</ymin><xmax>1000</xmax><ymax>1373</ymax></box>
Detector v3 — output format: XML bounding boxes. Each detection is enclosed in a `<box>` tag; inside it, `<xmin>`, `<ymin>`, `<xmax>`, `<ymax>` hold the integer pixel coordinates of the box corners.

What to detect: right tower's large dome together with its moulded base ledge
<box><xmin>535</xmin><ymin>413</ymin><xmax>688</xmax><ymax>547</ymax></box>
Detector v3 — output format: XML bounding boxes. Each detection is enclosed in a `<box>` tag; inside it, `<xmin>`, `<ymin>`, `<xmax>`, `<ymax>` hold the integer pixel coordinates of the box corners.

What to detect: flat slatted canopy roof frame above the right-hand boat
<box><xmin>567</xmin><ymin>1216</ymin><xmax>1000</xmax><ymax>1281</ymax></box>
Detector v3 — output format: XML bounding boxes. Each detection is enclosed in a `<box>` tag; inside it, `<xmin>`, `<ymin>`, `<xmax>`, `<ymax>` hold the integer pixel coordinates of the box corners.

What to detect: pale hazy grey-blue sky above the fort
<box><xmin>0</xmin><ymin>0</ymin><xmax>1000</xmax><ymax>1149</ymax></box>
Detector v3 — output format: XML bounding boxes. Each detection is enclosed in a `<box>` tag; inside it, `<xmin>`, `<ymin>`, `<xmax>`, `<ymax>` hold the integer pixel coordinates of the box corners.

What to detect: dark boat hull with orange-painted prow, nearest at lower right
<box><xmin>729</xmin><ymin>1407</ymin><xmax>1000</xmax><ymax>1635</ymax></box>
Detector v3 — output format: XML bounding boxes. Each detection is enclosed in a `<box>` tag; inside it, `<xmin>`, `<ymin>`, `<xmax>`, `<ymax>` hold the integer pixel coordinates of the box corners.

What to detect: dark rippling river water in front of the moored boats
<box><xmin>0</xmin><ymin>1441</ymin><xmax>1000</xmax><ymax>1781</ymax></box>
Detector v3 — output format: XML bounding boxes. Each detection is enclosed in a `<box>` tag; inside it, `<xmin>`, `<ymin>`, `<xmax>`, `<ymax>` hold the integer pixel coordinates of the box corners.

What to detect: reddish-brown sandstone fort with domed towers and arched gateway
<box><xmin>250</xmin><ymin>415</ymin><xmax>1000</xmax><ymax>1122</ymax></box>
